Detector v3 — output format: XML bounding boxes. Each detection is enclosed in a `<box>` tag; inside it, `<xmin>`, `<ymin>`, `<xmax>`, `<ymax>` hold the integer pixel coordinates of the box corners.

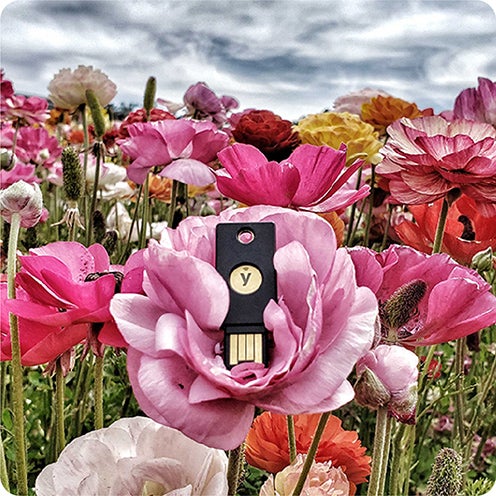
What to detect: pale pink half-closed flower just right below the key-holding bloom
<box><xmin>355</xmin><ymin>344</ymin><xmax>418</xmax><ymax>424</ymax></box>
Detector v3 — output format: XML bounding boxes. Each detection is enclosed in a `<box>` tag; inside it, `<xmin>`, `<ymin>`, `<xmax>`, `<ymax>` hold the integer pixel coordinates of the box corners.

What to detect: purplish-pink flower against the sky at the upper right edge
<box><xmin>453</xmin><ymin>77</ymin><xmax>496</xmax><ymax>127</ymax></box>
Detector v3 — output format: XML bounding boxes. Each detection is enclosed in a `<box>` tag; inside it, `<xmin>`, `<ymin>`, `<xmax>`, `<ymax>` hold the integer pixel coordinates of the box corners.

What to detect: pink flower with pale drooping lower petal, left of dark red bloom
<box><xmin>117</xmin><ymin>119</ymin><xmax>229</xmax><ymax>186</ymax></box>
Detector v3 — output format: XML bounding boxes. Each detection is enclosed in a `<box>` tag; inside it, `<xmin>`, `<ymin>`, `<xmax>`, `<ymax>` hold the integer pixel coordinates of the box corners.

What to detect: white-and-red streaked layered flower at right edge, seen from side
<box><xmin>377</xmin><ymin>116</ymin><xmax>496</xmax><ymax>217</ymax></box>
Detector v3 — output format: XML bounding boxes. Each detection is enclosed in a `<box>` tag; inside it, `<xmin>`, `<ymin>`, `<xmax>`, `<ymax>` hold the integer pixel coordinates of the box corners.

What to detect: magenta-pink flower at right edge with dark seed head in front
<box><xmin>349</xmin><ymin>245</ymin><xmax>496</xmax><ymax>346</ymax></box>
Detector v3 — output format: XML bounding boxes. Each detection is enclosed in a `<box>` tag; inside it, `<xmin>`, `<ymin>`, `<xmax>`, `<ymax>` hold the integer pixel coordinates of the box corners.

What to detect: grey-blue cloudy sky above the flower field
<box><xmin>0</xmin><ymin>0</ymin><xmax>496</xmax><ymax>119</ymax></box>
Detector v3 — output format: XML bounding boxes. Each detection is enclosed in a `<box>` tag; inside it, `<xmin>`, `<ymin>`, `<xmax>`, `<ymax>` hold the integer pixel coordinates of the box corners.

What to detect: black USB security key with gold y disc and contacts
<box><xmin>215</xmin><ymin>222</ymin><xmax>277</xmax><ymax>368</ymax></box>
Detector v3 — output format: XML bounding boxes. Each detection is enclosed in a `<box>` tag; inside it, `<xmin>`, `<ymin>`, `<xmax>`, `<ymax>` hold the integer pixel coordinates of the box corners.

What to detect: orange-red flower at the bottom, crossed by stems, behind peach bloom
<box><xmin>245</xmin><ymin>412</ymin><xmax>370</xmax><ymax>495</ymax></box>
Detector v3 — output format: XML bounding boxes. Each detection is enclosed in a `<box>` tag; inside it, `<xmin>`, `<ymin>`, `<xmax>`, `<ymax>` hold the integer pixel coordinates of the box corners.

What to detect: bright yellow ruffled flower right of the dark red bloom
<box><xmin>296</xmin><ymin>112</ymin><xmax>382</xmax><ymax>164</ymax></box>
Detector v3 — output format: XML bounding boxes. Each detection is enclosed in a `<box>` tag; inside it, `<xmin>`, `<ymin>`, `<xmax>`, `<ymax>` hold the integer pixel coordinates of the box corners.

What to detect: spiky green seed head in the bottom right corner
<box><xmin>425</xmin><ymin>448</ymin><xmax>463</xmax><ymax>496</ymax></box>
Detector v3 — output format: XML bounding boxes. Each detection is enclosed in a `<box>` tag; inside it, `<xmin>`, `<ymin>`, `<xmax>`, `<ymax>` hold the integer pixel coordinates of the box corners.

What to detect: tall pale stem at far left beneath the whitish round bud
<box><xmin>7</xmin><ymin>212</ymin><xmax>28</xmax><ymax>495</ymax></box>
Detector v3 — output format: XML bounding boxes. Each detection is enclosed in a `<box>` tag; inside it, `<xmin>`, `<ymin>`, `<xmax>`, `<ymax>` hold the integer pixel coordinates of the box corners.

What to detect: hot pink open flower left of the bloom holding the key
<box><xmin>5</xmin><ymin>241</ymin><xmax>142</xmax><ymax>364</ymax></box>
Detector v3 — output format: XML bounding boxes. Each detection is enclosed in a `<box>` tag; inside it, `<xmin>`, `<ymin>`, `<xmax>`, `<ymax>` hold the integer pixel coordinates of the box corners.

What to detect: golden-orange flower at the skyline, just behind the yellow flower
<box><xmin>361</xmin><ymin>95</ymin><xmax>424</xmax><ymax>136</ymax></box>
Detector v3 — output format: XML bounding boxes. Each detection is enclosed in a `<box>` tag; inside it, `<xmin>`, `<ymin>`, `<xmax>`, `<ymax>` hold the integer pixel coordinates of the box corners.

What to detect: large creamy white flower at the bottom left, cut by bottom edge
<box><xmin>35</xmin><ymin>417</ymin><xmax>227</xmax><ymax>496</ymax></box>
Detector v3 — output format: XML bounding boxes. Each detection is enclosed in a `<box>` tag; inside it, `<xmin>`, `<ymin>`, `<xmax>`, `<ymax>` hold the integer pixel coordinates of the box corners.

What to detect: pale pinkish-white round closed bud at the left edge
<box><xmin>0</xmin><ymin>181</ymin><xmax>43</xmax><ymax>227</ymax></box>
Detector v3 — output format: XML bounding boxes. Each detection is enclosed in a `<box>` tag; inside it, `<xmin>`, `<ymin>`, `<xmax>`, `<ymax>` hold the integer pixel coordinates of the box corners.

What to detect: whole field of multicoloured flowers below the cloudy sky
<box><xmin>0</xmin><ymin>66</ymin><xmax>496</xmax><ymax>496</ymax></box>
